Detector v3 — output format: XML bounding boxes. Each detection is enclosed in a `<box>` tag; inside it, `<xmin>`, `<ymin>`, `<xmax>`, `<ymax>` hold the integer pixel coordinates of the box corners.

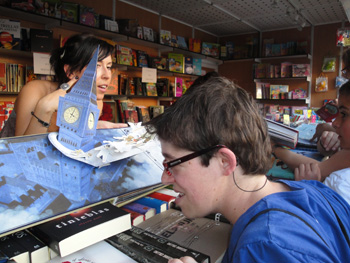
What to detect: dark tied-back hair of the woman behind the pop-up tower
<box><xmin>50</xmin><ymin>33</ymin><xmax>114</xmax><ymax>85</ymax></box>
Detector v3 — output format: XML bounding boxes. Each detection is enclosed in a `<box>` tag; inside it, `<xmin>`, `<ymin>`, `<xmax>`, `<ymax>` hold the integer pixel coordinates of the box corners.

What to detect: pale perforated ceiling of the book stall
<box><xmin>120</xmin><ymin>0</ymin><xmax>350</xmax><ymax>37</ymax></box>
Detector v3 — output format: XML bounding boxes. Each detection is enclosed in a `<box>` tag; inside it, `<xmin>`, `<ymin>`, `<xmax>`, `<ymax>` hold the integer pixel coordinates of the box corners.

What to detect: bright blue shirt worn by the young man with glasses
<box><xmin>222</xmin><ymin>180</ymin><xmax>350</xmax><ymax>263</ymax></box>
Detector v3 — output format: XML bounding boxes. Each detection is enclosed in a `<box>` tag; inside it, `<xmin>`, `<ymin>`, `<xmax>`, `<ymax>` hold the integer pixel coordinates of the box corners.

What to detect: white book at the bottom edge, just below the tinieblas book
<box><xmin>49</xmin><ymin>240</ymin><xmax>137</xmax><ymax>263</ymax></box>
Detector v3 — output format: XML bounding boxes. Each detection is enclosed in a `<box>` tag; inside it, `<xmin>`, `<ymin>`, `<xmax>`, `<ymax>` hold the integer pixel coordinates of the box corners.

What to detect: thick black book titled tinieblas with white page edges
<box><xmin>30</xmin><ymin>202</ymin><xmax>131</xmax><ymax>257</ymax></box>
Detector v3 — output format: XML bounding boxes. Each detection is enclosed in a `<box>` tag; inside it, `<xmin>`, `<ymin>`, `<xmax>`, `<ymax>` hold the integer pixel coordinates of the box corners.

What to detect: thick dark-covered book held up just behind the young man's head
<box><xmin>265</xmin><ymin>118</ymin><xmax>299</xmax><ymax>149</ymax></box>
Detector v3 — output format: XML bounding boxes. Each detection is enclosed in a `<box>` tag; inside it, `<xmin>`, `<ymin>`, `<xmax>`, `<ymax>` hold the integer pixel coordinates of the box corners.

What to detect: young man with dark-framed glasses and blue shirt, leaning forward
<box><xmin>147</xmin><ymin>77</ymin><xmax>350</xmax><ymax>263</ymax></box>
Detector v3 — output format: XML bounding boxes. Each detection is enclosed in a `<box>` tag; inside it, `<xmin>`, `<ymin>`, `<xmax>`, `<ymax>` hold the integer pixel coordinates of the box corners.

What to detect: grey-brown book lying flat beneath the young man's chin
<box><xmin>137</xmin><ymin>208</ymin><xmax>232</xmax><ymax>262</ymax></box>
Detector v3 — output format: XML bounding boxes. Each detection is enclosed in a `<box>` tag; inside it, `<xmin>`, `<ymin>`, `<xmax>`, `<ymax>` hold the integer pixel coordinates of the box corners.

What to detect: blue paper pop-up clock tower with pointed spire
<box><xmin>56</xmin><ymin>48</ymin><xmax>100</xmax><ymax>151</ymax></box>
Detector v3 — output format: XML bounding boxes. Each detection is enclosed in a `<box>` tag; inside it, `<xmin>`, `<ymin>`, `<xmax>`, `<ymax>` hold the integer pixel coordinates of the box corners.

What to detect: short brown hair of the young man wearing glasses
<box><xmin>147</xmin><ymin>77</ymin><xmax>271</xmax><ymax>174</ymax></box>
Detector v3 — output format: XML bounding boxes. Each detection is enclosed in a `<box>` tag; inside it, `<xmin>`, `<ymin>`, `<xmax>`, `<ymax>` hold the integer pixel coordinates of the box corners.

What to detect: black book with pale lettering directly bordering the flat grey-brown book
<box><xmin>124</xmin><ymin>227</ymin><xmax>210</xmax><ymax>263</ymax></box>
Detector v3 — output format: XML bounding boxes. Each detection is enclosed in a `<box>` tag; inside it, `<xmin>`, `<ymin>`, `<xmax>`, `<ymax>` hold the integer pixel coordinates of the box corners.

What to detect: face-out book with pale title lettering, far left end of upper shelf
<box><xmin>0</xmin><ymin>19</ymin><xmax>21</xmax><ymax>50</ymax></box>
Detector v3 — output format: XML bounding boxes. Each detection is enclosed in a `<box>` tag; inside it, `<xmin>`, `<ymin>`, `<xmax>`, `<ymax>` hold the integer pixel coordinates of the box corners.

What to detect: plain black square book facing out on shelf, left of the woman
<box><xmin>30</xmin><ymin>28</ymin><xmax>53</xmax><ymax>53</ymax></box>
